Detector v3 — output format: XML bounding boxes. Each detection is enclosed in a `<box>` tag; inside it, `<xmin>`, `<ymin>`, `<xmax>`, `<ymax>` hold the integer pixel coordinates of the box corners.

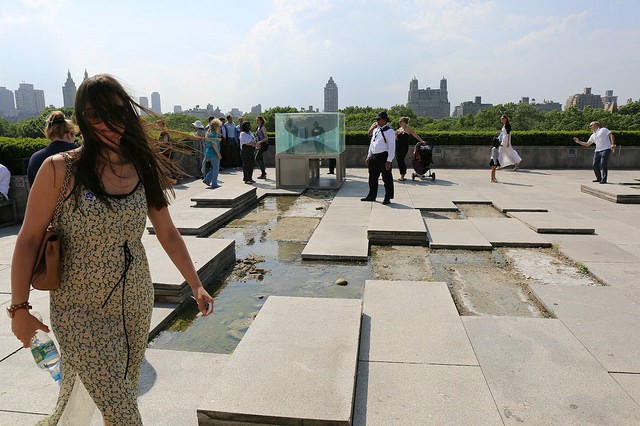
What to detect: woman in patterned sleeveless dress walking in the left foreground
<box><xmin>9</xmin><ymin>74</ymin><xmax>213</xmax><ymax>425</ymax></box>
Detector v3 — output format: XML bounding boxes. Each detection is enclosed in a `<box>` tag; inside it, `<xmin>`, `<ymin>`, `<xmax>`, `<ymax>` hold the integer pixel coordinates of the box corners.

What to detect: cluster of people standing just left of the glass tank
<box><xmin>192</xmin><ymin>115</ymin><xmax>269</xmax><ymax>189</ymax></box>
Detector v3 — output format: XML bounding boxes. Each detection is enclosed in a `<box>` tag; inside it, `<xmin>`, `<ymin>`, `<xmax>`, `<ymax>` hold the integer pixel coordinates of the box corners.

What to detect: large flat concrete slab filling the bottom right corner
<box><xmin>462</xmin><ymin>317</ymin><xmax>640</xmax><ymax>425</ymax></box>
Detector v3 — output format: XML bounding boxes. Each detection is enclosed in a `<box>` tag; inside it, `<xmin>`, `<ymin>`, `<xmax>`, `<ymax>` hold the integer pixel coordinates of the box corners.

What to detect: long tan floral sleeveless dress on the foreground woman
<box><xmin>41</xmin><ymin>175</ymin><xmax>154</xmax><ymax>425</ymax></box>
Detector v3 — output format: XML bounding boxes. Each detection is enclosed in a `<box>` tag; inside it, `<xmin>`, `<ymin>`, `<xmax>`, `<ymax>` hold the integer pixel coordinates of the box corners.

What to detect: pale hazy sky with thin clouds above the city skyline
<box><xmin>0</xmin><ymin>0</ymin><xmax>640</xmax><ymax>112</ymax></box>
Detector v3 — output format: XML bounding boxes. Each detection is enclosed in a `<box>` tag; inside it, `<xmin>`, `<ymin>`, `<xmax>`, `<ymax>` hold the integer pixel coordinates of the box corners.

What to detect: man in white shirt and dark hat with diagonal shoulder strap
<box><xmin>360</xmin><ymin>111</ymin><xmax>396</xmax><ymax>204</ymax></box>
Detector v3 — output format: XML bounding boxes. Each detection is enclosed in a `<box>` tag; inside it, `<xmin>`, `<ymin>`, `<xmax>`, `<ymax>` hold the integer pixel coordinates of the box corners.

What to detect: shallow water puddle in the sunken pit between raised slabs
<box><xmin>149</xmin><ymin>191</ymin><xmax>373</xmax><ymax>353</ymax></box>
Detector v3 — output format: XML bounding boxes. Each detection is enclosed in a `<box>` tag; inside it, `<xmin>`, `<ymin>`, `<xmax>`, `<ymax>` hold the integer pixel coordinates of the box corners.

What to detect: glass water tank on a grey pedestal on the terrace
<box><xmin>275</xmin><ymin>112</ymin><xmax>345</xmax><ymax>188</ymax></box>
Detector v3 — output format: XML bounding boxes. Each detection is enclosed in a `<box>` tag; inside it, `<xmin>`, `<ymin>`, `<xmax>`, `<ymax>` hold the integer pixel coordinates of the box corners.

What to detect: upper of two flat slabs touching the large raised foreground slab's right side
<box><xmin>360</xmin><ymin>280</ymin><xmax>478</xmax><ymax>365</ymax></box>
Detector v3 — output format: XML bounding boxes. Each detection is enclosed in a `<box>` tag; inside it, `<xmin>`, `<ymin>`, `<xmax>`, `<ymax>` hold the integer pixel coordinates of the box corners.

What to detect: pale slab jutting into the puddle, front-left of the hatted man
<box><xmin>302</xmin><ymin>221</ymin><xmax>369</xmax><ymax>260</ymax></box>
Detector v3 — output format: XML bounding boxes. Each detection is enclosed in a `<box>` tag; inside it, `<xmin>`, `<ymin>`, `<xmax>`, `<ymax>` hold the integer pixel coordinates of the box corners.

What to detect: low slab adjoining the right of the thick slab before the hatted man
<box><xmin>424</xmin><ymin>219</ymin><xmax>493</xmax><ymax>250</ymax></box>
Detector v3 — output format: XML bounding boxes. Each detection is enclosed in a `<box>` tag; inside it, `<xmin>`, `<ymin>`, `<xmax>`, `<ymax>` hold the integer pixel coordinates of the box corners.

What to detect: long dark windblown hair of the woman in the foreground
<box><xmin>73</xmin><ymin>74</ymin><xmax>175</xmax><ymax>209</ymax></box>
